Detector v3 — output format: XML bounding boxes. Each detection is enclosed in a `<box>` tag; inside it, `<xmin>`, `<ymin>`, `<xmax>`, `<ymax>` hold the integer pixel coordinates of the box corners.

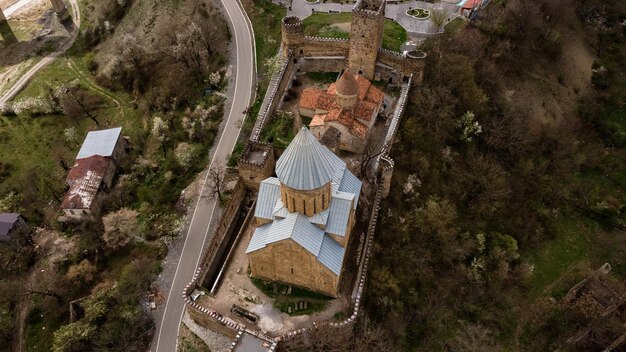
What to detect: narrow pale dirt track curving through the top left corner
<box><xmin>0</xmin><ymin>0</ymin><xmax>80</xmax><ymax>110</ymax></box>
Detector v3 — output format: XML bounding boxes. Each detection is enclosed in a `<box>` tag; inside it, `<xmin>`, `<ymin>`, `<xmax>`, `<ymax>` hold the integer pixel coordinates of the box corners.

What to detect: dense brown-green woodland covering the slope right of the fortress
<box><xmin>364</xmin><ymin>0</ymin><xmax>626</xmax><ymax>352</ymax></box>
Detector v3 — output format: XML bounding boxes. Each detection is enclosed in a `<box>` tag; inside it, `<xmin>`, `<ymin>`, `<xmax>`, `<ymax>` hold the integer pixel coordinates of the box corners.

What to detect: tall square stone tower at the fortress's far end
<box><xmin>348</xmin><ymin>0</ymin><xmax>385</xmax><ymax>80</ymax></box>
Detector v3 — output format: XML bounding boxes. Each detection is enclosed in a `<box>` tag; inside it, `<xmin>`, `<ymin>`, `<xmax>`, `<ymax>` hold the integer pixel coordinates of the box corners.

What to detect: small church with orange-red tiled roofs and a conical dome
<box><xmin>298</xmin><ymin>69</ymin><xmax>385</xmax><ymax>153</ymax></box>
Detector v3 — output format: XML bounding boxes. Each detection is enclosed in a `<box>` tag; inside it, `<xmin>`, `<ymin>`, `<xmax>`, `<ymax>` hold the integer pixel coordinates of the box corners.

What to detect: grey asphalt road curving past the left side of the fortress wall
<box><xmin>153</xmin><ymin>0</ymin><xmax>256</xmax><ymax>352</ymax></box>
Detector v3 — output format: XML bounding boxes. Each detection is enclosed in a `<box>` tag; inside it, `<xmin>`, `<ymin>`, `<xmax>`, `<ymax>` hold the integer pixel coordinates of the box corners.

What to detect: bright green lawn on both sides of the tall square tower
<box><xmin>302</xmin><ymin>12</ymin><xmax>407</xmax><ymax>51</ymax></box>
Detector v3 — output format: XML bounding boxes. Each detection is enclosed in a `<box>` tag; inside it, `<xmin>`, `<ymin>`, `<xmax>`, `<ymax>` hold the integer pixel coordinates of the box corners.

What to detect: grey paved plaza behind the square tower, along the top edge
<box><xmin>273</xmin><ymin>0</ymin><xmax>460</xmax><ymax>35</ymax></box>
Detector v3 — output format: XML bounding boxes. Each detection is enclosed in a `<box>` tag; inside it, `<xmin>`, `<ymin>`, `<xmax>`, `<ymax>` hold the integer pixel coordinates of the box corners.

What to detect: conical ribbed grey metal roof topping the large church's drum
<box><xmin>276</xmin><ymin>127</ymin><xmax>346</xmax><ymax>190</ymax></box>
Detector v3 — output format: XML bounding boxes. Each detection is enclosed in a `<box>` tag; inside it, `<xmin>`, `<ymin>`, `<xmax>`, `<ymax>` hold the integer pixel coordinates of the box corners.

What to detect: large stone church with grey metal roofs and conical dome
<box><xmin>246</xmin><ymin>127</ymin><xmax>361</xmax><ymax>297</ymax></box>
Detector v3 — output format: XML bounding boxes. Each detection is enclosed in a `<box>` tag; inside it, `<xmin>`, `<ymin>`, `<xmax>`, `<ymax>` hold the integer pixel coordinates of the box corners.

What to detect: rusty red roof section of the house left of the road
<box><xmin>61</xmin><ymin>155</ymin><xmax>111</xmax><ymax>209</ymax></box>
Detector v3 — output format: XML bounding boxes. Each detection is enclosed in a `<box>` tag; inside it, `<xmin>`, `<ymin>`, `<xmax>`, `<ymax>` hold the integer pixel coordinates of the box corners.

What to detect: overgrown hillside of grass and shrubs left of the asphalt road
<box><xmin>0</xmin><ymin>0</ymin><xmax>230</xmax><ymax>352</ymax></box>
